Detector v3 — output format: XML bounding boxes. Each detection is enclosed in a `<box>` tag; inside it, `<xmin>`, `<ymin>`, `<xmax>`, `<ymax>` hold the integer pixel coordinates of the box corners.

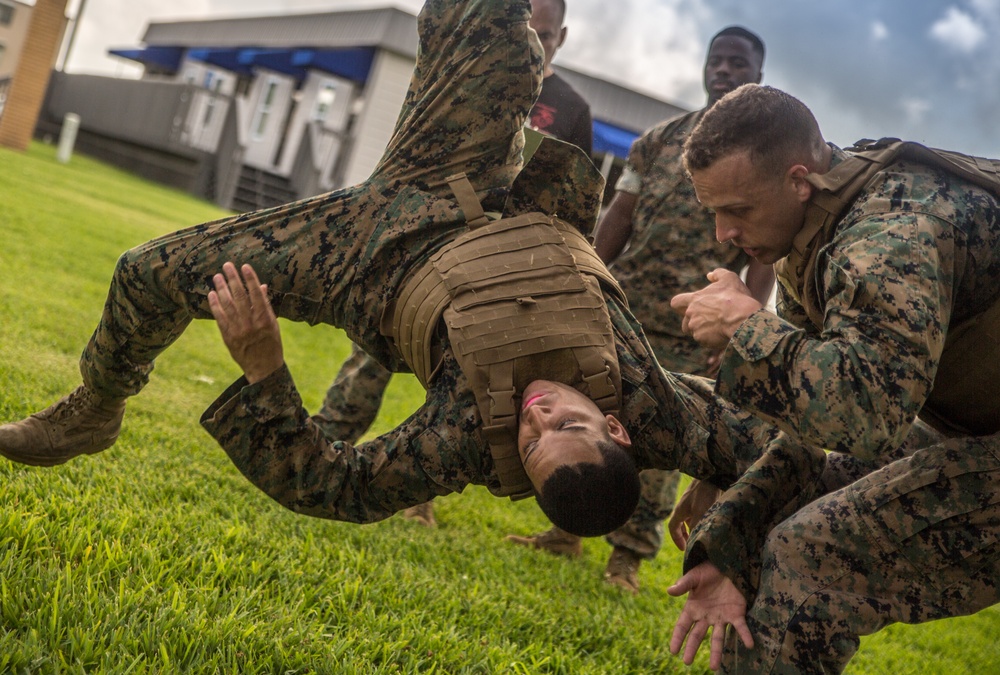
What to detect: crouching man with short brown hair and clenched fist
<box><xmin>672</xmin><ymin>87</ymin><xmax>1000</xmax><ymax>673</ymax></box>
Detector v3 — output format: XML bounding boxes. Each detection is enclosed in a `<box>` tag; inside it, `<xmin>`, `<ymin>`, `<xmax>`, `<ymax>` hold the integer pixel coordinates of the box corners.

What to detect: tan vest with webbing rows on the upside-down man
<box><xmin>384</xmin><ymin>173</ymin><xmax>625</xmax><ymax>499</ymax></box>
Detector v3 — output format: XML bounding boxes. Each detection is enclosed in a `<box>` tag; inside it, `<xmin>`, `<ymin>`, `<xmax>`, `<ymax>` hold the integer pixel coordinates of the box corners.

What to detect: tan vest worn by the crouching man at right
<box><xmin>775</xmin><ymin>138</ymin><xmax>1000</xmax><ymax>435</ymax></box>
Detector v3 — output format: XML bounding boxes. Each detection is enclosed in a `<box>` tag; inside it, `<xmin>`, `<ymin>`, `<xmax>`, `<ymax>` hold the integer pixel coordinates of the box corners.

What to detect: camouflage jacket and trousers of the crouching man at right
<box><xmin>685</xmin><ymin>148</ymin><xmax>1000</xmax><ymax>673</ymax></box>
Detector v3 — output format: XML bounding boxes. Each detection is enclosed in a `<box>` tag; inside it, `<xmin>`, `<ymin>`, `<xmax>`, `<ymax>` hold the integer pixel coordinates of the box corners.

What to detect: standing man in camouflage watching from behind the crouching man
<box><xmin>524</xmin><ymin>26</ymin><xmax>773</xmax><ymax>591</ymax></box>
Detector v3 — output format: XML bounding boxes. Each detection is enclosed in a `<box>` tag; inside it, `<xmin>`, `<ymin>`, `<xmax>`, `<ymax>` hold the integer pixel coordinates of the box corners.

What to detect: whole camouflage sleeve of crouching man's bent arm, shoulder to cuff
<box><xmin>716</xmin><ymin>212</ymin><xmax>955</xmax><ymax>458</ymax></box>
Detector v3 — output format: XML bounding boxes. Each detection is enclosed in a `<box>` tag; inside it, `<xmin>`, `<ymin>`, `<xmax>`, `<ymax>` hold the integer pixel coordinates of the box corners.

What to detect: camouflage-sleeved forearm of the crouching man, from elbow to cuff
<box><xmin>716</xmin><ymin>310</ymin><xmax>930</xmax><ymax>457</ymax></box>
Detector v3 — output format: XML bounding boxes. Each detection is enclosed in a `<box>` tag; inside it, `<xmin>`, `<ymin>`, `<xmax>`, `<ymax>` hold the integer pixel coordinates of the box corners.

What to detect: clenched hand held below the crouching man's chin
<box><xmin>670</xmin><ymin>268</ymin><xmax>764</xmax><ymax>350</ymax></box>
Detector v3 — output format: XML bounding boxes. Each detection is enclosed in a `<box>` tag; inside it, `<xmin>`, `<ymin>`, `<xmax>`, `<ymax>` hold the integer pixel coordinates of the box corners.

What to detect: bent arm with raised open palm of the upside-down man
<box><xmin>201</xmin><ymin>263</ymin><xmax>483</xmax><ymax>523</ymax></box>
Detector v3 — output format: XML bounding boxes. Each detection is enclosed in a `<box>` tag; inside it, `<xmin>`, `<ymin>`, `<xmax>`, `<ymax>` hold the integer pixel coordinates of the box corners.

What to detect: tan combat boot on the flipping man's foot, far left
<box><xmin>0</xmin><ymin>384</ymin><xmax>125</xmax><ymax>466</ymax></box>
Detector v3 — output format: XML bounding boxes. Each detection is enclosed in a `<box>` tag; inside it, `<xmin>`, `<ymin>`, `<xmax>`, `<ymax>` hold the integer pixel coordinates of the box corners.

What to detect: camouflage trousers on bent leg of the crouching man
<box><xmin>723</xmin><ymin>434</ymin><xmax>1000</xmax><ymax>673</ymax></box>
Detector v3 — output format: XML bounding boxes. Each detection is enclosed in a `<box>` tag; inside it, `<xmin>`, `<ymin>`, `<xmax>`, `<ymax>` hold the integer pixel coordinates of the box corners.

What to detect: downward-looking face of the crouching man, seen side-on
<box><xmin>691</xmin><ymin>151</ymin><xmax>811</xmax><ymax>265</ymax></box>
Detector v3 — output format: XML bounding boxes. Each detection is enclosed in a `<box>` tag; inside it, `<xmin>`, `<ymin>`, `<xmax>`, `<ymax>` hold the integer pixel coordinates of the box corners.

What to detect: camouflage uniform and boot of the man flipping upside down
<box><xmin>0</xmin><ymin>0</ymin><xmax>774</xmax><ymax>548</ymax></box>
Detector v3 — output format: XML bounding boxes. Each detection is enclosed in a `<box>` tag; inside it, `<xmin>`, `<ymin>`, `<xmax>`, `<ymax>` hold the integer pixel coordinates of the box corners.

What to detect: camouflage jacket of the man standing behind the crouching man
<box><xmin>612</xmin><ymin>109</ymin><xmax>749</xmax><ymax>374</ymax></box>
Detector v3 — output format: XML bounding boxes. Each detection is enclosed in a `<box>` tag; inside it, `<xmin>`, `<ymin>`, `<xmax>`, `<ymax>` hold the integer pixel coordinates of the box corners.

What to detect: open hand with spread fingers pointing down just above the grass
<box><xmin>667</xmin><ymin>562</ymin><xmax>753</xmax><ymax>670</ymax></box>
